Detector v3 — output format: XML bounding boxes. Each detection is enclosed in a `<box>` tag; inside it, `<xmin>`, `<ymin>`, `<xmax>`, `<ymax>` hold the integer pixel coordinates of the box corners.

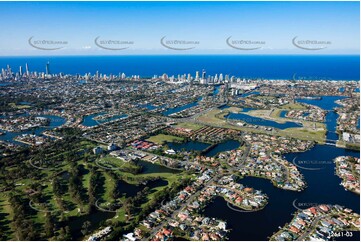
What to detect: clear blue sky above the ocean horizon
<box><xmin>0</xmin><ymin>2</ymin><xmax>360</xmax><ymax>56</ymax></box>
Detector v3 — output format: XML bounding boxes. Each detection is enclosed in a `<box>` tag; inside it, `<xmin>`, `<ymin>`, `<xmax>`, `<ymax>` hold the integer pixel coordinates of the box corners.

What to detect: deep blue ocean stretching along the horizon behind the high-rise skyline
<box><xmin>0</xmin><ymin>55</ymin><xmax>360</xmax><ymax>80</ymax></box>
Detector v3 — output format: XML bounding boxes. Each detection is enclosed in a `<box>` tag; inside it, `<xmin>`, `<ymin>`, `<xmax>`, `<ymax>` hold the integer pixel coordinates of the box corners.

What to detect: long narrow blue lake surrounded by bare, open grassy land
<box><xmin>225</xmin><ymin>113</ymin><xmax>302</xmax><ymax>129</ymax></box>
